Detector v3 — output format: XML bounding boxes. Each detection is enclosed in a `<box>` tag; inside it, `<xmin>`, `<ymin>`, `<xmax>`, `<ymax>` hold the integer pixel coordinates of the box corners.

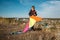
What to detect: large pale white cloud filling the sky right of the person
<box><xmin>37</xmin><ymin>1</ymin><xmax>60</xmax><ymax>18</ymax></box>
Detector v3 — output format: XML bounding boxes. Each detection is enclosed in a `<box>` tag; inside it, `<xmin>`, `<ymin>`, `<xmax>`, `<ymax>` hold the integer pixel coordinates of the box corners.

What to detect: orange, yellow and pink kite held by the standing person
<box><xmin>23</xmin><ymin>16</ymin><xmax>42</xmax><ymax>33</ymax></box>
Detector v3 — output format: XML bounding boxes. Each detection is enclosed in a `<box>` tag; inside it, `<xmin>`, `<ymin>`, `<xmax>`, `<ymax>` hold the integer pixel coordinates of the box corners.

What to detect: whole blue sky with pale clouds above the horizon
<box><xmin>0</xmin><ymin>0</ymin><xmax>60</xmax><ymax>18</ymax></box>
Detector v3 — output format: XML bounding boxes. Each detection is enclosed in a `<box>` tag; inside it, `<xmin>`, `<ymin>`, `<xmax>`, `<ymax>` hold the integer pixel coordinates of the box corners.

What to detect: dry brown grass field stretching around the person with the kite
<box><xmin>0</xmin><ymin>18</ymin><xmax>60</xmax><ymax>40</ymax></box>
